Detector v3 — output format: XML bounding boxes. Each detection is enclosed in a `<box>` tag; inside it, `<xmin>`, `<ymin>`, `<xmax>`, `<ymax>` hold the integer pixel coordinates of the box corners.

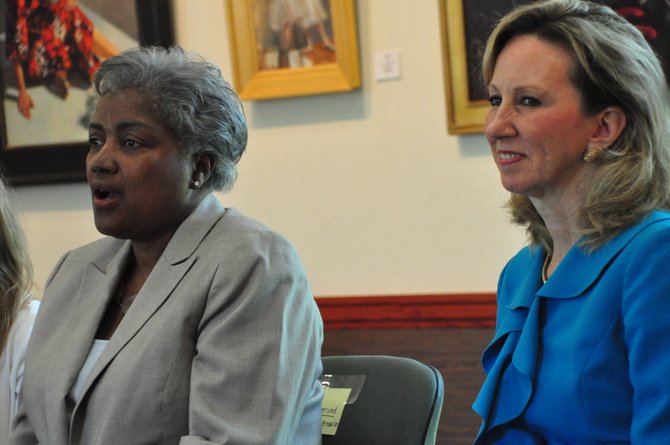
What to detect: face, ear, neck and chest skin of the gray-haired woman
<box><xmin>86</xmin><ymin>90</ymin><xmax>212</xmax><ymax>339</ymax></box>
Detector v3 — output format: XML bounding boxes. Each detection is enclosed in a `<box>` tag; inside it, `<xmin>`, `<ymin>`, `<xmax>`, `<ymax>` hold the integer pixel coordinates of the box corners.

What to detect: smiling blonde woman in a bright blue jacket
<box><xmin>473</xmin><ymin>0</ymin><xmax>670</xmax><ymax>445</ymax></box>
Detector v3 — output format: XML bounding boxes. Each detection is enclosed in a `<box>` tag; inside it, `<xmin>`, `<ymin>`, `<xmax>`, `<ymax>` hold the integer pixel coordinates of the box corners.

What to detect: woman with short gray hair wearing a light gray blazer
<box><xmin>11</xmin><ymin>47</ymin><xmax>323</xmax><ymax>445</ymax></box>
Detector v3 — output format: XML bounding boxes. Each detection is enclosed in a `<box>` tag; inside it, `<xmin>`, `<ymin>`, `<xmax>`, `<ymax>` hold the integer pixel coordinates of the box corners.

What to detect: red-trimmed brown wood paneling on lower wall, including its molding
<box><xmin>316</xmin><ymin>293</ymin><xmax>496</xmax><ymax>445</ymax></box>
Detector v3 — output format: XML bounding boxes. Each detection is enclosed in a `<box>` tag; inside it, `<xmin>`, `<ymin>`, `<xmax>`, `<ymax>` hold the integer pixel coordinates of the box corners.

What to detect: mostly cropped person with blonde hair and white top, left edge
<box><xmin>0</xmin><ymin>174</ymin><xmax>39</xmax><ymax>443</ymax></box>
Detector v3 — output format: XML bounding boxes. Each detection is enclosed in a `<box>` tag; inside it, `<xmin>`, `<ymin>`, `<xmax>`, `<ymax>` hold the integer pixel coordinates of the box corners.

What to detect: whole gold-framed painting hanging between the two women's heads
<box><xmin>227</xmin><ymin>0</ymin><xmax>360</xmax><ymax>100</ymax></box>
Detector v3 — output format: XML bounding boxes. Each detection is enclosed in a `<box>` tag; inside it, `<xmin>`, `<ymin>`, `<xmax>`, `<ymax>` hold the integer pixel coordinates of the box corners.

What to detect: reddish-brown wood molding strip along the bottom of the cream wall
<box><xmin>316</xmin><ymin>293</ymin><xmax>496</xmax><ymax>330</ymax></box>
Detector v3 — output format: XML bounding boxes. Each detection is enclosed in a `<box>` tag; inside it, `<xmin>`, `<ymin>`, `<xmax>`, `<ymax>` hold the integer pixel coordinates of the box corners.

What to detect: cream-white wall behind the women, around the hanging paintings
<box><xmin>9</xmin><ymin>0</ymin><xmax>524</xmax><ymax>296</ymax></box>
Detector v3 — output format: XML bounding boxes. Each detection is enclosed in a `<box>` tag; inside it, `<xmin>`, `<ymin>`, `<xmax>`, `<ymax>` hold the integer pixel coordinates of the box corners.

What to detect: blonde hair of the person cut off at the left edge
<box><xmin>0</xmin><ymin>177</ymin><xmax>33</xmax><ymax>351</ymax></box>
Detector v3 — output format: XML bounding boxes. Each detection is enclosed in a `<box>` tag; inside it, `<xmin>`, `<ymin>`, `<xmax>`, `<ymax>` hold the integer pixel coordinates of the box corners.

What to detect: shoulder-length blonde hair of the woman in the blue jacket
<box><xmin>483</xmin><ymin>0</ymin><xmax>670</xmax><ymax>253</ymax></box>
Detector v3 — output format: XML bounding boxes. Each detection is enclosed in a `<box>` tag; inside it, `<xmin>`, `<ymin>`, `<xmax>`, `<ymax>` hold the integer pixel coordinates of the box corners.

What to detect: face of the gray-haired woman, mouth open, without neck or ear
<box><xmin>86</xmin><ymin>90</ymin><xmax>198</xmax><ymax>242</ymax></box>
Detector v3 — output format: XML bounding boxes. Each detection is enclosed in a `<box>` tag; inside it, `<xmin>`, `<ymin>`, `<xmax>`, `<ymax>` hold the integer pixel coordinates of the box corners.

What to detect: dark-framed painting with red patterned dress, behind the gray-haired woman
<box><xmin>0</xmin><ymin>0</ymin><xmax>174</xmax><ymax>185</ymax></box>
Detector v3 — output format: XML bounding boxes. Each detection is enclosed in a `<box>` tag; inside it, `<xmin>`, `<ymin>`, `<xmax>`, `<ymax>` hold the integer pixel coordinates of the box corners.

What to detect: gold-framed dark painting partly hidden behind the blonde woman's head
<box><xmin>438</xmin><ymin>0</ymin><xmax>670</xmax><ymax>134</ymax></box>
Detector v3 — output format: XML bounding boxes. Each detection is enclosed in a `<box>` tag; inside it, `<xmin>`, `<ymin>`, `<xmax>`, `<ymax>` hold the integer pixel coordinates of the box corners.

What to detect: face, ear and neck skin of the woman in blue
<box><xmin>485</xmin><ymin>35</ymin><xmax>626</xmax><ymax>275</ymax></box>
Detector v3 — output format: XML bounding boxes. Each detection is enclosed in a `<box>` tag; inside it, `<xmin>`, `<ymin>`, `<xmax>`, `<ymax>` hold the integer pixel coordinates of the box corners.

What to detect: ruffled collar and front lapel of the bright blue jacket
<box><xmin>473</xmin><ymin>212</ymin><xmax>670</xmax><ymax>445</ymax></box>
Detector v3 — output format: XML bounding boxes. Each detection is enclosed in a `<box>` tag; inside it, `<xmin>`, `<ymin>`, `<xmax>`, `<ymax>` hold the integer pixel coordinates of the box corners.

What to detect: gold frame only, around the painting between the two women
<box><xmin>226</xmin><ymin>0</ymin><xmax>361</xmax><ymax>100</ymax></box>
